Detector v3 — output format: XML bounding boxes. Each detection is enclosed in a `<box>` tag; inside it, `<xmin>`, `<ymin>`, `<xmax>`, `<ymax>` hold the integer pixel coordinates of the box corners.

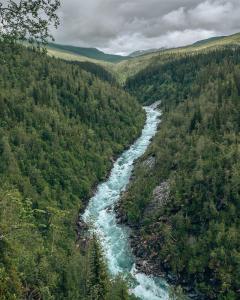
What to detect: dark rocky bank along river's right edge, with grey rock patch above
<box><xmin>115</xmin><ymin>179</ymin><xmax>206</xmax><ymax>300</ymax></box>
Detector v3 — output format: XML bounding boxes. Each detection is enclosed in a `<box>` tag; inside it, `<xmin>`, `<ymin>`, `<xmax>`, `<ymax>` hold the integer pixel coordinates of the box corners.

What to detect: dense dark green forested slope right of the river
<box><xmin>121</xmin><ymin>47</ymin><xmax>240</xmax><ymax>300</ymax></box>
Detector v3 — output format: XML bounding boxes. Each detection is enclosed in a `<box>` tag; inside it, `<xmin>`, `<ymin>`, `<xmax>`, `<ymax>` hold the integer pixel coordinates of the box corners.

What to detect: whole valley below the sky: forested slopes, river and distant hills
<box><xmin>0</xmin><ymin>28</ymin><xmax>240</xmax><ymax>300</ymax></box>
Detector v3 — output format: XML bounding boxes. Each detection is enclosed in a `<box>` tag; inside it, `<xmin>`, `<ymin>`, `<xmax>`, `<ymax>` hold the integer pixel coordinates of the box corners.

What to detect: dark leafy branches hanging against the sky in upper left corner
<box><xmin>0</xmin><ymin>0</ymin><xmax>60</xmax><ymax>43</ymax></box>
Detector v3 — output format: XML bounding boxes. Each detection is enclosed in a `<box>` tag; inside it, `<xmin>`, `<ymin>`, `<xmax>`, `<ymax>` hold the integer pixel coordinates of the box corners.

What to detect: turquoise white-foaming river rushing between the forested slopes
<box><xmin>82</xmin><ymin>104</ymin><xmax>168</xmax><ymax>300</ymax></box>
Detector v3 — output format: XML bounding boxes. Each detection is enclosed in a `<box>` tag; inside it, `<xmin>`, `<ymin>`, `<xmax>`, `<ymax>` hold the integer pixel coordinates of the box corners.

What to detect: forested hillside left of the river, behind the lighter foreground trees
<box><xmin>0</xmin><ymin>42</ymin><xmax>144</xmax><ymax>208</ymax></box>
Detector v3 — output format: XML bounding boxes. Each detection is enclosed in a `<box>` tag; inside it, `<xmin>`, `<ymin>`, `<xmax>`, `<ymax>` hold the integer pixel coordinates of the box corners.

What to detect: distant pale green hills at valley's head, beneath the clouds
<box><xmin>48</xmin><ymin>33</ymin><xmax>240</xmax><ymax>85</ymax></box>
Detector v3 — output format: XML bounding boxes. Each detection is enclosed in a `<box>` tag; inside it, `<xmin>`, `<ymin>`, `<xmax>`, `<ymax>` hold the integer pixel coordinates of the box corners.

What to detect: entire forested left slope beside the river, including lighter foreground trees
<box><xmin>0</xmin><ymin>43</ymin><xmax>142</xmax><ymax>300</ymax></box>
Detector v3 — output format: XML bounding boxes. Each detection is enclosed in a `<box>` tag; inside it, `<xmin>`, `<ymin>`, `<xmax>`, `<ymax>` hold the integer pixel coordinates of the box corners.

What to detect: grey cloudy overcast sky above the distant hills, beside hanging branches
<box><xmin>54</xmin><ymin>0</ymin><xmax>240</xmax><ymax>54</ymax></box>
